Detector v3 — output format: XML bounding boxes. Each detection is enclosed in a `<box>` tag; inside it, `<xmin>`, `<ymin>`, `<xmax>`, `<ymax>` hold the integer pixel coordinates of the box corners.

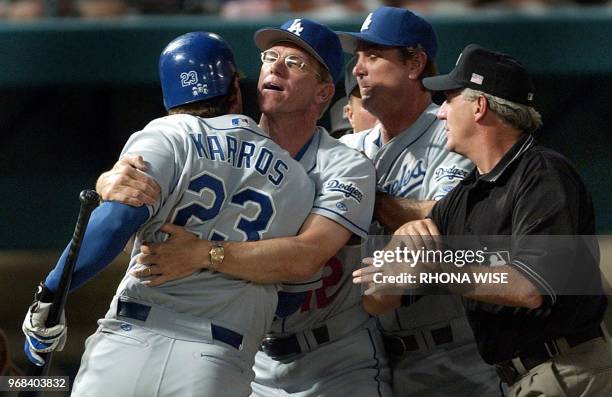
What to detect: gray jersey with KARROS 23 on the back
<box><xmin>110</xmin><ymin>115</ymin><xmax>314</xmax><ymax>334</ymax></box>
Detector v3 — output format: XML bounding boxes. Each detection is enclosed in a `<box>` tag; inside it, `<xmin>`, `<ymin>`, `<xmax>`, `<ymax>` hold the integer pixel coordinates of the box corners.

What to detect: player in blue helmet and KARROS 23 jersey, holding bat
<box><xmin>23</xmin><ymin>32</ymin><xmax>314</xmax><ymax>396</ymax></box>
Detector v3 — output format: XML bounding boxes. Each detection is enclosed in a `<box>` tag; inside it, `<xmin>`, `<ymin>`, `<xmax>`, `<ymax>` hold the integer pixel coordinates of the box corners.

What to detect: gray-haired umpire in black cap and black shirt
<box><xmin>398</xmin><ymin>44</ymin><xmax>612</xmax><ymax>397</ymax></box>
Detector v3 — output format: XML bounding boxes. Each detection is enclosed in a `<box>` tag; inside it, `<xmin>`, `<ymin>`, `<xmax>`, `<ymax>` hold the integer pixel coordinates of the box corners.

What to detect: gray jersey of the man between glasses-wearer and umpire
<box><xmin>341</xmin><ymin>104</ymin><xmax>473</xmax><ymax>331</ymax></box>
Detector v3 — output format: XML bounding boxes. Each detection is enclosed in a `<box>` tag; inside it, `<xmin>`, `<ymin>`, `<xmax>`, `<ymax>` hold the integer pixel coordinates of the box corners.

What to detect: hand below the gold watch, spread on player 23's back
<box><xmin>130</xmin><ymin>223</ymin><xmax>212</xmax><ymax>287</ymax></box>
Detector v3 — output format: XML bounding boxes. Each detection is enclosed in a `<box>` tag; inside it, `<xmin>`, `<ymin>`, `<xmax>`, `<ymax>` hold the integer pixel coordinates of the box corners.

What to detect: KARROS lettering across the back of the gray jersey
<box><xmin>189</xmin><ymin>134</ymin><xmax>289</xmax><ymax>186</ymax></box>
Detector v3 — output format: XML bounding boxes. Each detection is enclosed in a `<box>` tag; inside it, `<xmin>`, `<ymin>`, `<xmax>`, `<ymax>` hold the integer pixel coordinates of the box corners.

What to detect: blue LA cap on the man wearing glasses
<box><xmin>254</xmin><ymin>18</ymin><xmax>344</xmax><ymax>83</ymax></box>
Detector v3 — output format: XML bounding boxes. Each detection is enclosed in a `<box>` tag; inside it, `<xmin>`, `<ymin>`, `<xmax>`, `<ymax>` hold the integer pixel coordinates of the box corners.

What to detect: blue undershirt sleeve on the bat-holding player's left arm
<box><xmin>45</xmin><ymin>201</ymin><xmax>149</xmax><ymax>292</ymax></box>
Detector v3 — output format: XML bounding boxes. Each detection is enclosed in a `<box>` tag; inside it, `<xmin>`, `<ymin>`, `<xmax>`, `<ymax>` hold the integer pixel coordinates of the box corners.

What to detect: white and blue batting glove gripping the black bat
<box><xmin>21</xmin><ymin>301</ymin><xmax>68</xmax><ymax>367</ymax></box>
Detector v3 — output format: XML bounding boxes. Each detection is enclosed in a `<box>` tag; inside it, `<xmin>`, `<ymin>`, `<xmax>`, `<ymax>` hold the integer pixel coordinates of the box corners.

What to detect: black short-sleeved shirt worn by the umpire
<box><xmin>430</xmin><ymin>134</ymin><xmax>607</xmax><ymax>364</ymax></box>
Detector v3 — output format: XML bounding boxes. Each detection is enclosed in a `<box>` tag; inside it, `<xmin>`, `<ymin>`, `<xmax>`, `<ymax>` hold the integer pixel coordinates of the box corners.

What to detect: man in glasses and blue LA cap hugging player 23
<box><xmin>98</xmin><ymin>19</ymin><xmax>391</xmax><ymax>396</ymax></box>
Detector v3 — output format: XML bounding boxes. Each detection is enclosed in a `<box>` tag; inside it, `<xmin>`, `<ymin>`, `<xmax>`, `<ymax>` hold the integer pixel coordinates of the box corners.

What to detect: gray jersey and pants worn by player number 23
<box><xmin>75</xmin><ymin>115</ymin><xmax>315</xmax><ymax>396</ymax></box>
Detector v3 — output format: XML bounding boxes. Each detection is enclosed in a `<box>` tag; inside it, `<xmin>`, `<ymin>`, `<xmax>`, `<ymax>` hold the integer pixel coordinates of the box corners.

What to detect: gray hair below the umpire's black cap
<box><xmin>461</xmin><ymin>88</ymin><xmax>542</xmax><ymax>133</ymax></box>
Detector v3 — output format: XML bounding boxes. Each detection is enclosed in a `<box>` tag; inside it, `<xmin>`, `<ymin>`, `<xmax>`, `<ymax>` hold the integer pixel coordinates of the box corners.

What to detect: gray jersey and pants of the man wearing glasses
<box><xmin>252</xmin><ymin>127</ymin><xmax>391</xmax><ymax>397</ymax></box>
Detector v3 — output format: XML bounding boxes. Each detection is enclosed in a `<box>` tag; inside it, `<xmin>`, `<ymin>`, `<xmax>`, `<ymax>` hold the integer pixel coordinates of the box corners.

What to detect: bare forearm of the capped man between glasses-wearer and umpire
<box><xmin>374</xmin><ymin>192</ymin><xmax>436</xmax><ymax>232</ymax></box>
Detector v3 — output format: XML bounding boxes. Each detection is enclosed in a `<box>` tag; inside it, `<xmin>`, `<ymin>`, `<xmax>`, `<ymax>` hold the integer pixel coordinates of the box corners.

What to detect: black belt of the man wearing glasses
<box><xmin>259</xmin><ymin>325</ymin><xmax>330</xmax><ymax>362</ymax></box>
